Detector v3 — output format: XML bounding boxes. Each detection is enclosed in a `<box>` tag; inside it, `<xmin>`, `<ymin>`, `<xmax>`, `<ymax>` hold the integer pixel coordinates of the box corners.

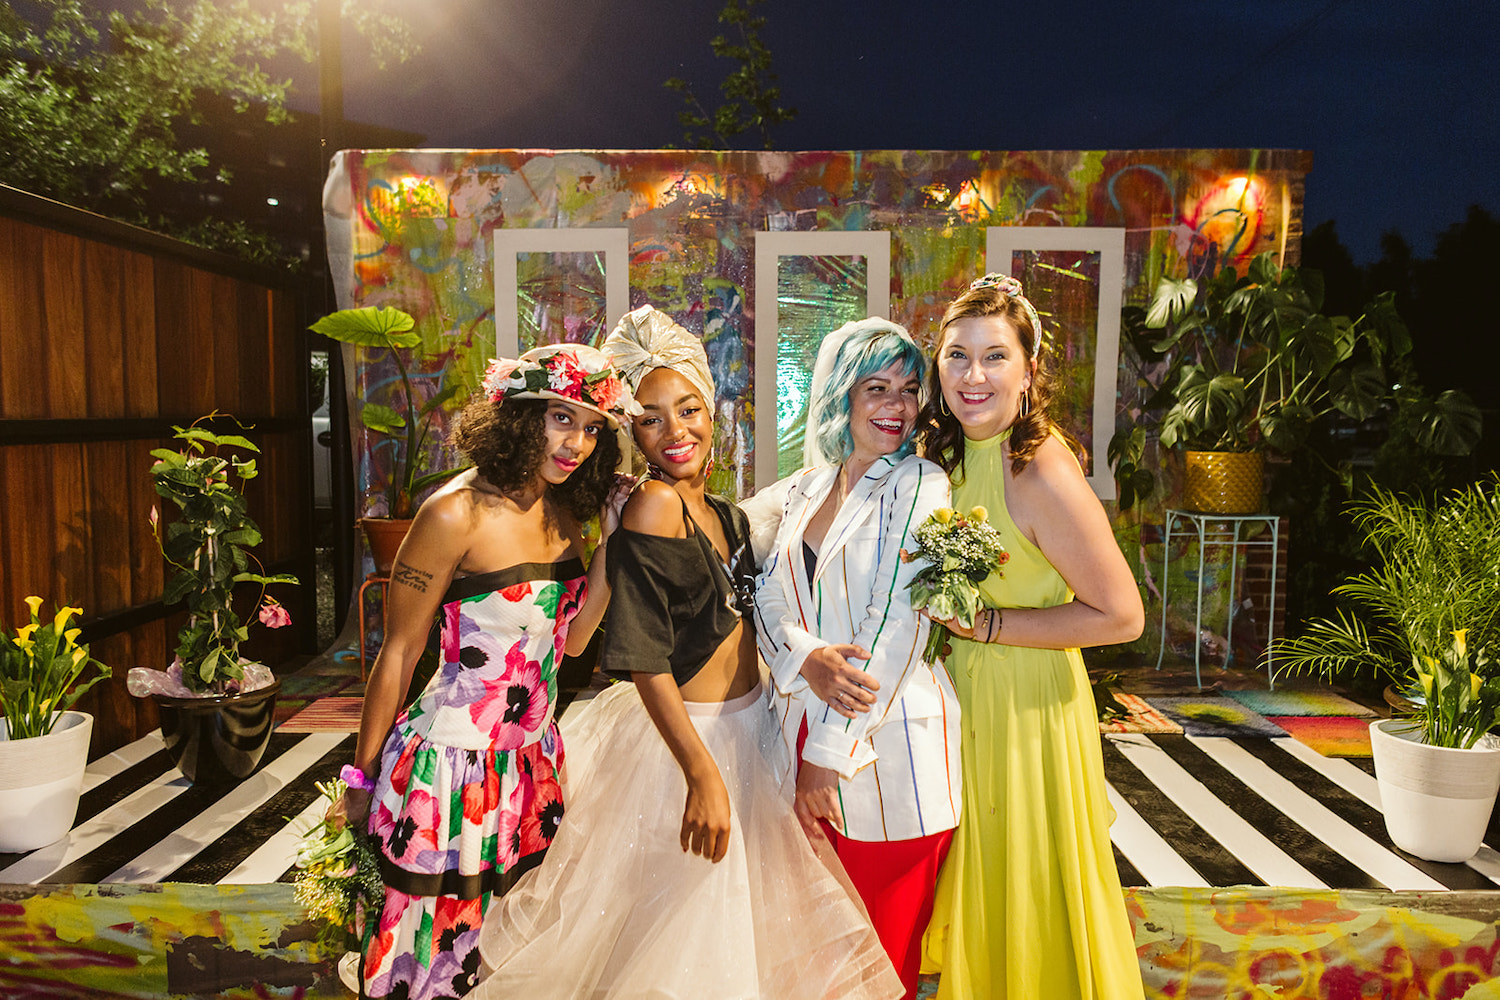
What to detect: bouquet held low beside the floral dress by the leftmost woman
<box><xmin>293</xmin><ymin>778</ymin><xmax>386</xmax><ymax>948</ymax></box>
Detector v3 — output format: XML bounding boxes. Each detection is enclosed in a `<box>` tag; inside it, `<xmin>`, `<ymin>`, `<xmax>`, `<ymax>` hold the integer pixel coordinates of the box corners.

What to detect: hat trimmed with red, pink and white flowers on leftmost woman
<box><xmin>480</xmin><ymin>343</ymin><xmax>641</xmax><ymax>472</ymax></box>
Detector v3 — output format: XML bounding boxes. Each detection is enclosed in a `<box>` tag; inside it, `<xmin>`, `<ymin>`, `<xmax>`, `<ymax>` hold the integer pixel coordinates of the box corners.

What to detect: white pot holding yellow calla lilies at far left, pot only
<box><xmin>0</xmin><ymin>712</ymin><xmax>93</xmax><ymax>853</ymax></box>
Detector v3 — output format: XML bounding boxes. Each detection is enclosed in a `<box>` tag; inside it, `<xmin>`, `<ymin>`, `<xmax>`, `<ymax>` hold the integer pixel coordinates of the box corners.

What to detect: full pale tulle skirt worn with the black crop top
<box><xmin>468</xmin><ymin>684</ymin><xmax>902</xmax><ymax>1000</ymax></box>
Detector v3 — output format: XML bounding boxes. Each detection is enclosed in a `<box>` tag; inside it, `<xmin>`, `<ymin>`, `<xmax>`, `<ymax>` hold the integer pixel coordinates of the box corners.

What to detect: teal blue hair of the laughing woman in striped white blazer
<box><xmin>807</xmin><ymin>316</ymin><xmax>927</xmax><ymax>463</ymax></box>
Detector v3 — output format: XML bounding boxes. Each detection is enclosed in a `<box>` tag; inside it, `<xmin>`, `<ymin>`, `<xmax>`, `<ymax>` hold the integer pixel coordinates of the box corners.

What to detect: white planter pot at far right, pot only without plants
<box><xmin>1370</xmin><ymin>718</ymin><xmax>1500</xmax><ymax>862</ymax></box>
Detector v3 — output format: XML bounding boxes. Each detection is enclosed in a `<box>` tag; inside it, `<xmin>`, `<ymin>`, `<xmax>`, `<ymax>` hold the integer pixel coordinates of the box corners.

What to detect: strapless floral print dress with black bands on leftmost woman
<box><xmin>362</xmin><ymin>558</ymin><xmax>587</xmax><ymax>1000</ymax></box>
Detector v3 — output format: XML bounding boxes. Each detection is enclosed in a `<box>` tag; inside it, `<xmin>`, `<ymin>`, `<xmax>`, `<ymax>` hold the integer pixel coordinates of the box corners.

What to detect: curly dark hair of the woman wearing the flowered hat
<box><xmin>453</xmin><ymin>393</ymin><xmax>620</xmax><ymax>522</ymax></box>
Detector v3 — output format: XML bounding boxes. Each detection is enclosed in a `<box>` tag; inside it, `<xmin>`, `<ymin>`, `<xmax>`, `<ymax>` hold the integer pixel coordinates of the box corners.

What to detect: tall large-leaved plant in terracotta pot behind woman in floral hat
<box><xmin>311</xmin><ymin>306</ymin><xmax>462</xmax><ymax>570</ymax></box>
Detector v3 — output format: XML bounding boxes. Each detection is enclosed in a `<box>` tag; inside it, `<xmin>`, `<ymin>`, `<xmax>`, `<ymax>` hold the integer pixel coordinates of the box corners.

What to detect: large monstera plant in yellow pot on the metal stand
<box><xmin>1109</xmin><ymin>253</ymin><xmax>1481</xmax><ymax>514</ymax></box>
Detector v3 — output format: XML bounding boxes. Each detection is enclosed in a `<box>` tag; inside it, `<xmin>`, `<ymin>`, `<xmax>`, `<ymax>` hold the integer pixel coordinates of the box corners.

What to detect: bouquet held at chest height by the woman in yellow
<box><xmin>902</xmin><ymin>507</ymin><xmax>1011</xmax><ymax>663</ymax></box>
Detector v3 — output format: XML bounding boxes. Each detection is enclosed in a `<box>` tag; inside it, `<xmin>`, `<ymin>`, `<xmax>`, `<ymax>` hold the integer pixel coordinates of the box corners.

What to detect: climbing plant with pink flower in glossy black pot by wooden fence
<box><xmin>129</xmin><ymin>412</ymin><xmax>299</xmax><ymax>783</ymax></box>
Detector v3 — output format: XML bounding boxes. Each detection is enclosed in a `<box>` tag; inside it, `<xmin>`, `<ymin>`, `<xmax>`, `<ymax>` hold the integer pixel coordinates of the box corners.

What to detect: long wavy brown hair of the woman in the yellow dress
<box><xmin>917</xmin><ymin>286</ymin><xmax>1082</xmax><ymax>481</ymax></box>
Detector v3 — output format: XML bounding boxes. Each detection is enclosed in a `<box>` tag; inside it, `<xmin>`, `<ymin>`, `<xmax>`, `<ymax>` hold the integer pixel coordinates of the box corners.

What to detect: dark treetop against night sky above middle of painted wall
<box><xmin>665</xmin><ymin>0</ymin><xmax>797</xmax><ymax>150</ymax></box>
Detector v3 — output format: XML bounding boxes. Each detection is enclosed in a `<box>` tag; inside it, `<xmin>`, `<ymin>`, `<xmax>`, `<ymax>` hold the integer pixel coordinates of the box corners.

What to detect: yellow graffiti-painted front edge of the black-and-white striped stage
<box><xmin>0</xmin><ymin>883</ymin><xmax>1500</xmax><ymax>1000</ymax></box>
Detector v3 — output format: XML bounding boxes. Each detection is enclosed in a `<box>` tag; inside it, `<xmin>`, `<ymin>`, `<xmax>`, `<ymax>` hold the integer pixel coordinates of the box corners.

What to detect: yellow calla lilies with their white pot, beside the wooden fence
<box><xmin>0</xmin><ymin>597</ymin><xmax>110</xmax><ymax>852</ymax></box>
